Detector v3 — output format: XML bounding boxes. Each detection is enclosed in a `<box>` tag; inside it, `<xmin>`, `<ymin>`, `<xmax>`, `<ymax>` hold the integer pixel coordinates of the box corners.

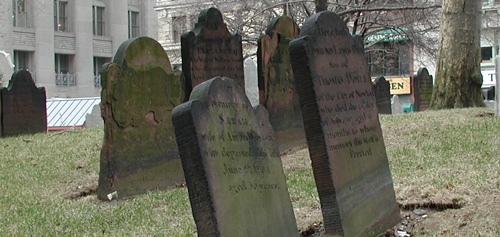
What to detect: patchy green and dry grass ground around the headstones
<box><xmin>0</xmin><ymin>108</ymin><xmax>500</xmax><ymax>236</ymax></box>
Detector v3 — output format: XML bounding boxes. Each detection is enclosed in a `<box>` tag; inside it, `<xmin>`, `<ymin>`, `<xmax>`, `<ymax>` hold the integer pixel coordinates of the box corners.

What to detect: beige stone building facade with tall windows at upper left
<box><xmin>0</xmin><ymin>0</ymin><xmax>158</xmax><ymax>98</ymax></box>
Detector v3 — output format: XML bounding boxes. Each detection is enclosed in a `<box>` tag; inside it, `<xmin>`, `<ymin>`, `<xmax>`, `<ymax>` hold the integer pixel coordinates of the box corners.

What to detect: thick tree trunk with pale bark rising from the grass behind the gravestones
<box><xmin>430</xmin><ymin>0</ymin><xmax>484</xmax><ymax>109</ymax></box>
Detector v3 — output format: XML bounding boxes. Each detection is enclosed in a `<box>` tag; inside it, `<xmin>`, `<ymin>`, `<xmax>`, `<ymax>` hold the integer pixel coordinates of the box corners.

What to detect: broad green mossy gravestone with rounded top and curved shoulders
<box><xmin>97</xmin><ymin>37</ymin><xmax>184</xmax><ymax>200</ymax></box>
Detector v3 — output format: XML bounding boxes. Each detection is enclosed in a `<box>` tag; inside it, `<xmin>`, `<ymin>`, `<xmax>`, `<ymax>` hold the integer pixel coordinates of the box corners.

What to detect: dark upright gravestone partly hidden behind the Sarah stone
<box><xmin>181</xmin><ymin>7</ymin><xmax>245</xmax><ymax>100</ymax></box>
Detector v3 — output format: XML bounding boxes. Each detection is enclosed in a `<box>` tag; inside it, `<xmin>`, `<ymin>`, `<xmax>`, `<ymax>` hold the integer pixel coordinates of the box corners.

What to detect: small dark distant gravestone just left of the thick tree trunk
<box><xmin>411</xmin><ymin>68</ymin><xmax>434</xmax><ymax>111</ymax></box>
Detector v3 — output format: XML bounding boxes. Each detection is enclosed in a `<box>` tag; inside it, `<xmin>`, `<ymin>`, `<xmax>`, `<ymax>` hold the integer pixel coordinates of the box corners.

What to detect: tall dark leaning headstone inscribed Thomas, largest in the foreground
<box><xmin>290</xmin><ymin>11</ymin><xmax>399</xmax><ymax>236</ymax></box>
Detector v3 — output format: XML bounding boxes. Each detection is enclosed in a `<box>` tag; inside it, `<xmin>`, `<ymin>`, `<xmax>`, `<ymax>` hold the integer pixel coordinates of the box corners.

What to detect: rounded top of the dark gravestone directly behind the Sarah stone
<box><xmin>194</xmin><ymin>7</ymin><xmax>230</xmax><ymax>37</ymax></box>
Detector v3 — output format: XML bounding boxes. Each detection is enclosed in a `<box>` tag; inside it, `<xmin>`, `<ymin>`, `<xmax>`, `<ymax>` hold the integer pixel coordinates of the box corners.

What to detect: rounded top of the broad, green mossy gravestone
<box><xmin>113</xmin><ymin>36</ymin><xmax>172</xmax><ymax>72</ymax></box>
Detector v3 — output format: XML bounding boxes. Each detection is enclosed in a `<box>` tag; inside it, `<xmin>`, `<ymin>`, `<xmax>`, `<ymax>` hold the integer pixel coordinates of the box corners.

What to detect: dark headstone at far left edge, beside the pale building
<box><xmin>0</xmin><ymin>70</ymin><xmax>47</xmax><ymax>137</ymax></box>
